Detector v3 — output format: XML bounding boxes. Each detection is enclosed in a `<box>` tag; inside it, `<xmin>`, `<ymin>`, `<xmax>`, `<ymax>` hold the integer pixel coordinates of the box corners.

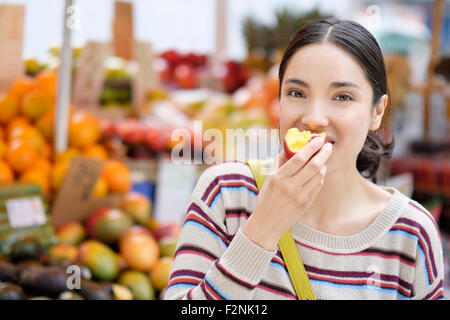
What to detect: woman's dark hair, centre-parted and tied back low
<box><xmin>278</xmin><ymin>17</ymin><xmax>394</xmax><ymax>183</ymax></box>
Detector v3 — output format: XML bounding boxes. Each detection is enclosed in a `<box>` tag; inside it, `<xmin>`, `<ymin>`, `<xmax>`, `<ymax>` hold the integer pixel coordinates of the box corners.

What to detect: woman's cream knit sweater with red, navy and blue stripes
<box><xmin>165</xmin><ymin>162</ymin><xmax>444</xmax><ymax>300</ymax></box>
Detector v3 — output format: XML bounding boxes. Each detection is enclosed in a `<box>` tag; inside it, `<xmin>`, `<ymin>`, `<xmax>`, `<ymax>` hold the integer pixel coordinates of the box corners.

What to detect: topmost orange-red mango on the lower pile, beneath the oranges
<box><xmin>120</xmin><ymin>192</ymin><xmax>152</xmax><ymax>224</ymax></box>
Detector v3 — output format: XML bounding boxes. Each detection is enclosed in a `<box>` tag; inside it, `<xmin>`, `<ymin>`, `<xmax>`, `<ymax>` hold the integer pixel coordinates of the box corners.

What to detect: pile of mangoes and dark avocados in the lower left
<box><xmin>0</xmin><ymin>192</ymin><xmax>180</xmax><ymax>300</ymax></box>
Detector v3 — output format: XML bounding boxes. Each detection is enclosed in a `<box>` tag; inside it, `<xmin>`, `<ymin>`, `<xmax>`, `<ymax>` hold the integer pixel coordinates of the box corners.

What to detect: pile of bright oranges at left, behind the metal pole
<box><xmin>0</xmin><ymin>70</ymin><xmax>131</xmax><ymax>197</ymax></box>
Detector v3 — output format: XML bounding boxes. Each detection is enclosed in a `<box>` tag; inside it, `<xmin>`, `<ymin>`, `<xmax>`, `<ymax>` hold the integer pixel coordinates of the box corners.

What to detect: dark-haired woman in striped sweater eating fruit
<box><xmin>166</xmin><ymin>18</ymin><xmax>444</xmax><ymax>300</ymax></box>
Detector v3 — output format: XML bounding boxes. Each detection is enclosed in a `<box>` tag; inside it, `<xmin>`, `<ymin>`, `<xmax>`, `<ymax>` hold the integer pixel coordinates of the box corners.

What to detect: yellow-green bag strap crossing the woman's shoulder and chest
<box><xmin>247</xmin><ymin>159</ymin><xmax>317</xmax><ymax>300</ymax></box>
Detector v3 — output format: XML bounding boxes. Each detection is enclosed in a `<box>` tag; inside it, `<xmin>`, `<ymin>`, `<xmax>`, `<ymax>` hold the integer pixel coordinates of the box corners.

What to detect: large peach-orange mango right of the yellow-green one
<box><xmin>119</xmin><ymin>231</ymin><xmax>159</xmax><ymax>272</ymax></box>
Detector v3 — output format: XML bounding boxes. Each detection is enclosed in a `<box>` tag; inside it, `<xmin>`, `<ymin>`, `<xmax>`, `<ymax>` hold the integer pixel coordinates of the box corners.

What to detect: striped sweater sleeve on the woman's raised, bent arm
<box><xmin>164</xmin><ymin>164</ymin><xmax>276</xmax><ymax>300</ymax></box>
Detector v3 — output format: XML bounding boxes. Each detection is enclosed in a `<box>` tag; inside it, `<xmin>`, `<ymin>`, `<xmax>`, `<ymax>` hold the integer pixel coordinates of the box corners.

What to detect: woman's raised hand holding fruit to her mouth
<box><xmin>242</xmin><ymin>138</ymin><xmax>332</xmax><ymax>250</ymax></box>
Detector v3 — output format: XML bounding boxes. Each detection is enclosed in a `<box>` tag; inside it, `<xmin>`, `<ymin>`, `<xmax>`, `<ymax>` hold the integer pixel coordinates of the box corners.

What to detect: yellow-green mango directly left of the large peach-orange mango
<box><xmin>78</xmin><ymin>240</ymin><xmax>120</xmax><ymax>280</ymax></box>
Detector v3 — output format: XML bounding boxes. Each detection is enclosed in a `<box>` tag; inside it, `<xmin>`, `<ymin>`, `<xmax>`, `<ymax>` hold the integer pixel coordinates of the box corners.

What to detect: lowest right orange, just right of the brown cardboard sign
<box><xmin>103</xmin><ymin>160</ymin><xmax>131</xmax><ymax>193</ymax></box>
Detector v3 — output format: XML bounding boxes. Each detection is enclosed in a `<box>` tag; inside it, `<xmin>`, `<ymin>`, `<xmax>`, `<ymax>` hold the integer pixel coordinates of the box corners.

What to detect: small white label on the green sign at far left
<box><xmin>6</xmin><ymin>197</ymin><xmax>47</xmax><ymax>228</ymax></box>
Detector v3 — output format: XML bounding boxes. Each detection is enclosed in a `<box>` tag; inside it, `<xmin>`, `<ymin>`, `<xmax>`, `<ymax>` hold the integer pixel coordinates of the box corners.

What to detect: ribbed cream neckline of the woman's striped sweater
<box><xmin>291</xmin><ymin>187</ymin><xmax>408</xmax><ymax>253</ymax></box>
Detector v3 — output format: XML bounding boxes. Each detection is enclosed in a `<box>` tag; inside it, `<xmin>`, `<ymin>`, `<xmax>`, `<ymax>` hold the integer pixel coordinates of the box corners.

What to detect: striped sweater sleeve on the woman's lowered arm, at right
<box><xmin>412</xmin><ymin>202</ymin><xmax>444</xmax><ymax>300</ymax></box>
